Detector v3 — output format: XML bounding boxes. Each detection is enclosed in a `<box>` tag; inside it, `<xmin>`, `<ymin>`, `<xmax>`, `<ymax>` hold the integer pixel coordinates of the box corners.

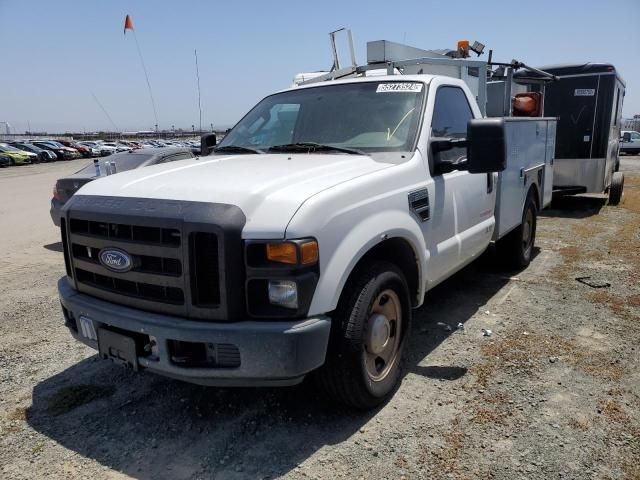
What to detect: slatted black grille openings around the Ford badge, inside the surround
<box><xmin>62</xmin><ymin>214</ymin><xmax>226</xmax><ymax>319</ymax></box>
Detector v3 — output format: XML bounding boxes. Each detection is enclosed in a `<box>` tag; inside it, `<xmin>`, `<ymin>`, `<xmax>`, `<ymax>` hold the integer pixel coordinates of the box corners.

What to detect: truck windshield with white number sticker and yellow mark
<box><xmin>218</xmin><ymin>81</ymin><xmax>425</xmax><ymax>153</ymax></box>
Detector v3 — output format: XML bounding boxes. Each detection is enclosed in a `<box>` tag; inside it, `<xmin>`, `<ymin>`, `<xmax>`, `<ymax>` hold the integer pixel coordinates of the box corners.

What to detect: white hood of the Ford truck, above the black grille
<box><xmin>77</xmin><ymin>154</ymin><xmax>393</xmax><ymax>238</ymax></box>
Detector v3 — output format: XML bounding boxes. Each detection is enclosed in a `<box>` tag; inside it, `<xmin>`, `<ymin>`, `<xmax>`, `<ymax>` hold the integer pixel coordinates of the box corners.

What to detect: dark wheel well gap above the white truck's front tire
<box><xmin>352</xmin><ymin>238</ymin><xmax>420</xmax><ymax>307</ymax></box>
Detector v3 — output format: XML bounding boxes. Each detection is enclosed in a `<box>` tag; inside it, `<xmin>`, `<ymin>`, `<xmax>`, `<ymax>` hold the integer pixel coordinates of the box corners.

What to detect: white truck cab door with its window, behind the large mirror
<box><xmin>425</xmin><ymin>86</ymin><xmax>495</xmax><ymax>284</ymax></box>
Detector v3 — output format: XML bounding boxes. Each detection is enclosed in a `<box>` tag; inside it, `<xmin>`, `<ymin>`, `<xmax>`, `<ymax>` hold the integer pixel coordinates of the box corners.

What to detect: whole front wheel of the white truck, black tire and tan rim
<box><xmin>316</xmin><ymin>261</ymin><xmax>411</xmax><ymax>409</ymax></box>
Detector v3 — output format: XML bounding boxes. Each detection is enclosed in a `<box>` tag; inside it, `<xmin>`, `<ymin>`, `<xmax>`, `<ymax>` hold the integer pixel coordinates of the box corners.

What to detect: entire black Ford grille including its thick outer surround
<box><xmin>62</xmin><ymin>194</ymin><xmax>245</xmax><ymax>321</ymax></box>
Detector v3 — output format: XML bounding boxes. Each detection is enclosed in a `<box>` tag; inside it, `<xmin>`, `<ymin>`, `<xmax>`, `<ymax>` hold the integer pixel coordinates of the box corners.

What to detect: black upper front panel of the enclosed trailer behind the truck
<box><xmin>544</xmin><ymin>75</ymin><xmax>600</xmax><ymax>158</ymax></box>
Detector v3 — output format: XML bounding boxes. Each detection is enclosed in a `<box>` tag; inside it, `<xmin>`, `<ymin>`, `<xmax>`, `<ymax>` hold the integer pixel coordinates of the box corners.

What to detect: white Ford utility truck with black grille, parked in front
<box><xmin>58</xmin><ymin>67</ymin><xmax>555</xmax><ymax>408</ymax></box>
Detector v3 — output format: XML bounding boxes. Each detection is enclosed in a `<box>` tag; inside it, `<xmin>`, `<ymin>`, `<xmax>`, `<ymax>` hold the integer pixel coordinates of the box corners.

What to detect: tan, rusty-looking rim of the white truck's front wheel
<box><xmin>364</xmin><ymin>289</ymin><xmax>402</xmax><ymax>382</ymax></box>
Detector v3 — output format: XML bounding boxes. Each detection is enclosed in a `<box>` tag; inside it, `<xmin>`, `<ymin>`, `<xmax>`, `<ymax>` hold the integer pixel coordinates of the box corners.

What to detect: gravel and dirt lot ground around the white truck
<box><xmin>0</xmin><ymin>157</ymin><xmax>640</xmax><ymax>479</ymax></box>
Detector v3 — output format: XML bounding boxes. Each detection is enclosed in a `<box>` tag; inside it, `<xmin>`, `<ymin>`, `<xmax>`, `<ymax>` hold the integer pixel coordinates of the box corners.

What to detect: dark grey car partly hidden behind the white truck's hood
<box><xmin>50</xmin><ymin>148</ymin><xmax>194</xmax><ymax>226</ymax></box>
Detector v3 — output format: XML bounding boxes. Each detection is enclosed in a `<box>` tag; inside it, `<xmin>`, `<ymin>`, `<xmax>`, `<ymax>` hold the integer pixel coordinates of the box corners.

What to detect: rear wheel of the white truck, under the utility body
<box><xmin>496</xmin><ymin>191</ymin><xmax>538</xmax><ymax>269</ymax></box>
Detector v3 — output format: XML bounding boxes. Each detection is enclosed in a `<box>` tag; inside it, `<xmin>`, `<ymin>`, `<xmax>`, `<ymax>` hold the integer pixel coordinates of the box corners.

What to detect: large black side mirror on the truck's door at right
<box><xmin>466</xmin><ymin>118</ymin><xmax>507</xmax><ymax>173</ymax></box>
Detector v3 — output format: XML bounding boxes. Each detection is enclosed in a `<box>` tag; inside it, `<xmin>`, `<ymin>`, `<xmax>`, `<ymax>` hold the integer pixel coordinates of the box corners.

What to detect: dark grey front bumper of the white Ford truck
<box><xmin>58</xmin><ymin>277</ymin><xmax>331</xmax><ymax>386</ymax></box>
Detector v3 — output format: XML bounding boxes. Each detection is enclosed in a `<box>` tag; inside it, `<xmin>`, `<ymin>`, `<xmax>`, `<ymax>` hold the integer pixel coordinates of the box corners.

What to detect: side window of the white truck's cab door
<box><xmin>431</xmin><ymin>87</ymin><xmax>473</xmax><ymax>138</ymax></box>
